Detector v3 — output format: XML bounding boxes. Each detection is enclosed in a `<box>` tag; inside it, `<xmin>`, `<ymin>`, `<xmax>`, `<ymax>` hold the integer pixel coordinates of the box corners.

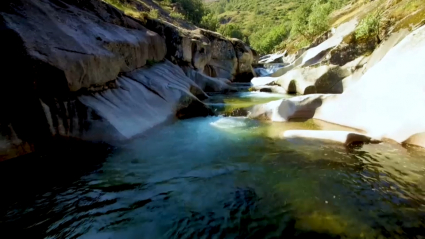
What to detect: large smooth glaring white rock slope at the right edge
<box><xmin>315</xmin><ymin>26</ymin><xmax>425</xmax><ymax>147</ymax></box>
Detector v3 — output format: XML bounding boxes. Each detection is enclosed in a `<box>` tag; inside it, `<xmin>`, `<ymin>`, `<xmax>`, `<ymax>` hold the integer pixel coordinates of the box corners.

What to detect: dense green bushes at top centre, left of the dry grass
<box><xmin>202</xmin><ymin>0</ymin><xmax>348</xmax><ymax>54</ymax></box>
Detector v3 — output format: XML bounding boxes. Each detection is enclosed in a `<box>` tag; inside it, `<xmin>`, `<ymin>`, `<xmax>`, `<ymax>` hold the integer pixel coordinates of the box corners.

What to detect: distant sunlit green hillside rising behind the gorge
<box><xmin>206</xmin><ymin>0</ymin><xmax>424</xmax><ymax>54</ymax></box>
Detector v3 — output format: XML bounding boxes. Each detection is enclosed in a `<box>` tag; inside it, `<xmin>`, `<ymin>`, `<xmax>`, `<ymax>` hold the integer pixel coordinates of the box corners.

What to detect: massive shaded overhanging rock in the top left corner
<box><xmin>0</xmin><ymin>0</ymin><xmax>167</xmax><ymax>94</ymax></box>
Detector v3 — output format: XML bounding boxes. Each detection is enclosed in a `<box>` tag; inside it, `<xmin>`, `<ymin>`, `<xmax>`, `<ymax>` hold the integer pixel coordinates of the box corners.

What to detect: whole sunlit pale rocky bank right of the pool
<box><xmin>249</xmin><ymin>13</ymin><xmax>425</xmax><ymax>147</ymax></box>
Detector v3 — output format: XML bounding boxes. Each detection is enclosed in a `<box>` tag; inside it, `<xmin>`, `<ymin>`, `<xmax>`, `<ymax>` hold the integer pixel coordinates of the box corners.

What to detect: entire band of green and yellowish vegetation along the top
<box><xmin>103</xmin><ymin>0</ymin><xmax>425</xmax><ymax>54</ymax></box>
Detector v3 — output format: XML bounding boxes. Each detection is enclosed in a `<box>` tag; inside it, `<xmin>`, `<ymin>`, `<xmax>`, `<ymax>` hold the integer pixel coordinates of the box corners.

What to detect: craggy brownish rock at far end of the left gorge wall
<box><xmin>145</xmin><ymin>23</ymin><xmax>255</xmax><ymax>81</ymax></box>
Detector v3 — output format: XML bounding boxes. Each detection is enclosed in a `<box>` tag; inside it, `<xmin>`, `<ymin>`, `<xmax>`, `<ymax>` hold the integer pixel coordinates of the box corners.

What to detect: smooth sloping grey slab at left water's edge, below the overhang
<box><xmin>0</xmin><ymin>61</ymin><xmax>211</xmax><ymax>161</ymax></box>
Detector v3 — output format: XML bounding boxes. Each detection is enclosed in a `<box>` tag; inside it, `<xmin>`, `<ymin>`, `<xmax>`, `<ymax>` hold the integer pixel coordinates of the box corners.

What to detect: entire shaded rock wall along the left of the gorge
<box><xmin>0</xmin><ymin>0</ymin><xmax>254</xmax><ymax>161</ymax></box>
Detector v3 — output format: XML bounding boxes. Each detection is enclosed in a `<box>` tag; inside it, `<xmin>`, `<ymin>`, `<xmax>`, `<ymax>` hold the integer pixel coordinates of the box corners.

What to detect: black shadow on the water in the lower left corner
<box><xmin>0</xmin><ymin>140</ymin><xmax>112</xmax><ymax>238</ymax></box>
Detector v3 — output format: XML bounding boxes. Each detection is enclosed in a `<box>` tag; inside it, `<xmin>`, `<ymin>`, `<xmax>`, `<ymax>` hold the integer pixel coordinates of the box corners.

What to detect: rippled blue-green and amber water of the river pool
<box><xmin>0</xmin><ymin>90</ymin><xmax>425</xmax><ymax>239</ymax></box>
